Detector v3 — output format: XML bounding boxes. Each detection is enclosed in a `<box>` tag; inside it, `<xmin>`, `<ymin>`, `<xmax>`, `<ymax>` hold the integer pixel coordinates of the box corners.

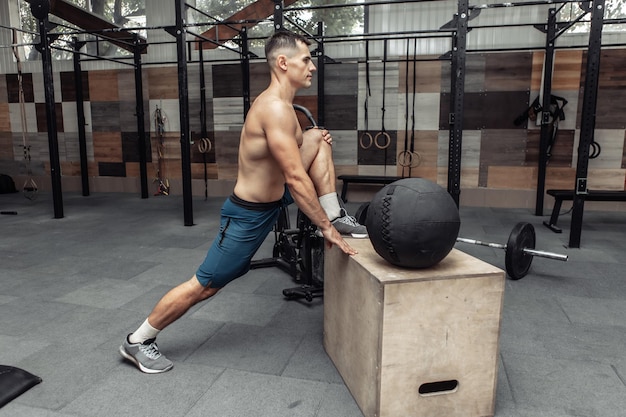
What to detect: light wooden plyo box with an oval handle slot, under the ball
<box><xmin>324</xmin><ymin>239</ymin><xmax>505</xmax><ymax>417</ymax></box>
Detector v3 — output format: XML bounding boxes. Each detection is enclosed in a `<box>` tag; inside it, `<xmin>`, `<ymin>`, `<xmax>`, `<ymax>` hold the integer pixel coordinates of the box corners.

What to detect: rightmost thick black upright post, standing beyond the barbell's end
<box><xmin>569</xmin><ymin>0</ymin><xmax>604</xmax><ymax>248</ymax></box>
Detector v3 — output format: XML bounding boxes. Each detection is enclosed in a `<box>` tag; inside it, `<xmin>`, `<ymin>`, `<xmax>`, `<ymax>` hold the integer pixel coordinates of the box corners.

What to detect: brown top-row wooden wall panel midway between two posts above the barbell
<box><xmin>485</xmin><ymin>52</ymin><xmax>532</xmax><ymax>91</ymax></box>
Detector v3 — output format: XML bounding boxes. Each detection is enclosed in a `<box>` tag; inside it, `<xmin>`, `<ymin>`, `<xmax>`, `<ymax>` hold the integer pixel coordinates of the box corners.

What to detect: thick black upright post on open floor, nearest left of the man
<box><xmin>175</xmin><ymin>0</ymin><xmax>193</xmax><ymax>226</ymax></box>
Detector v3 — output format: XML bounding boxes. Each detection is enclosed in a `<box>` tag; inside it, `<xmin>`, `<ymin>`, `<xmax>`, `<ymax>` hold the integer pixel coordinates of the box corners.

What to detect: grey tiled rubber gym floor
<box><xmin>0</xmin><ymin>192</ymin><xmax>626</xmax><ymax>417</ymax></box>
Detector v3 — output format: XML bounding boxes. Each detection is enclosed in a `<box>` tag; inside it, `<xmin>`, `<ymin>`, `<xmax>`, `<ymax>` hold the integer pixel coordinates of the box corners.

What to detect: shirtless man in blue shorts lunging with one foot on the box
<box><xmin>119</xmin><ymin>32</ymin><xmax>367</xmax><ymax>373</ymax></box>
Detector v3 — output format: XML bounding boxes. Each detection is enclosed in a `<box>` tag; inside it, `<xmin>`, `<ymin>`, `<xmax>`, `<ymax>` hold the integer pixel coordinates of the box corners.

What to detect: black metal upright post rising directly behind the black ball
<box><xmin>448</xmin><ymin>0</ymin><xmax>469</xmax><ymax>207</ymax></box>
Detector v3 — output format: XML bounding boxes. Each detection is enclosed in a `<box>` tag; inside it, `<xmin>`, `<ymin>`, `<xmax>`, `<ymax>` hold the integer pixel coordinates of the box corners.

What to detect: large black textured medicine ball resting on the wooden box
<box><xmin>365</xmin><ymin>178</ymin><xmax>461</xmax><ymax>268</ymax></box>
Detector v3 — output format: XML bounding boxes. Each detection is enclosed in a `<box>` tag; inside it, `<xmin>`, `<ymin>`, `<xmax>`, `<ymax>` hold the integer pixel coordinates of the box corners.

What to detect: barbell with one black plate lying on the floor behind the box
<box><xmin>456</xmin><ymin>222</ymin><xmax>568</xmax><ymax>280</ymax></box>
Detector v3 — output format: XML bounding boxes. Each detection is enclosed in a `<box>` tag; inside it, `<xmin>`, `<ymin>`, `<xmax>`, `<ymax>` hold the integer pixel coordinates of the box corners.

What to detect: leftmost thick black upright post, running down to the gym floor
<box><xmin>30</xmin><ymin>1</ymin><xmax>63</xmax><ymax>219</ymax></box>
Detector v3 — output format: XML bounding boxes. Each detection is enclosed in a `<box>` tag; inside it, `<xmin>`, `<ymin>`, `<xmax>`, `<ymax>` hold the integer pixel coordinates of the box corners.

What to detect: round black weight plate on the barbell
<box><xmin>504</xmin><ymin>222</ymin><xmax>535</xmax><ymax>280</ymax></box>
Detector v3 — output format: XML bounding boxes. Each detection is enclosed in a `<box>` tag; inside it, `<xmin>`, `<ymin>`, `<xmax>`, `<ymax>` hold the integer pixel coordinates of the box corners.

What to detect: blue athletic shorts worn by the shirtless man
<box><xmin>196</xmin><ymin>187</ymin><xmax>293</xmax><ymax>288</ymax></box>
